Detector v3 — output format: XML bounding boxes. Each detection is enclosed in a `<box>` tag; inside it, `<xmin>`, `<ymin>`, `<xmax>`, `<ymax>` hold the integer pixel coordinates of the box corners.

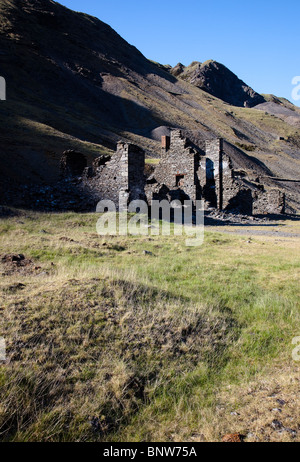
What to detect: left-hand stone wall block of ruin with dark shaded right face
<box><xmin>84</xmin><ymin>142</ymin><xmax>145</xmax><ymax>208</ymax></box>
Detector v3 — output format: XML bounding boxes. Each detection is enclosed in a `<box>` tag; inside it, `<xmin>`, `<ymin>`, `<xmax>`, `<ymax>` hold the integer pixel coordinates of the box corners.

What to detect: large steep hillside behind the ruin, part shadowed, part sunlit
<box><xmin>0</xmin><ymin>0</ymin><xmax>300</xmax><ymax>211</ymax></box>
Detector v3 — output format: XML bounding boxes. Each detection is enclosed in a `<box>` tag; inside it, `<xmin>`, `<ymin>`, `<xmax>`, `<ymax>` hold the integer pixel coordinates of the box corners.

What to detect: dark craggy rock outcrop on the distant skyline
<box><xmin>171</xmin><ymin>61</ymin><xmax>265</xmax><ymax>107</ymax></box>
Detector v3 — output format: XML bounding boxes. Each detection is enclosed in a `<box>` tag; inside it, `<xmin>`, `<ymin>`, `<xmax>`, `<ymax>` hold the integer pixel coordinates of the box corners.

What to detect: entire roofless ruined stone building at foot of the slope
<box><xmin>63</xmin><ymin>130</ymin><xmax>285</xmax><ymax>215</ymax></box>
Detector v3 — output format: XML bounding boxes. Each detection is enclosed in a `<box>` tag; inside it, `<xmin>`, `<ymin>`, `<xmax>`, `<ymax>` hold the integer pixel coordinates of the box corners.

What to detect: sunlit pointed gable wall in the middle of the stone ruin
<box><xmin>152</xmin><ymin>130</ymin><xmax>201</xmax><ymax>202</ymax></box>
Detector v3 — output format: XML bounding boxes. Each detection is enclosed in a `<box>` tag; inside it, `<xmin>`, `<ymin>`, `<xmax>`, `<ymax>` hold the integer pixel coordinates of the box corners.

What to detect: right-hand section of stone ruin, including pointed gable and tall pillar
<box><xmin>145</xmin><ymin>130</ymin><xmax>285</xmax><ymax>215</ymax></box>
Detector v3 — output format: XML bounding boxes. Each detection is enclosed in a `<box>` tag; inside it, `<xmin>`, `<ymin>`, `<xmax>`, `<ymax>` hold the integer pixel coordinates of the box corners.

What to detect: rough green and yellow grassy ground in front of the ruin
<box><xmin>0</xmin><ymin>212</ymin><xmax>300</xmax><ymax>441</ymax></box>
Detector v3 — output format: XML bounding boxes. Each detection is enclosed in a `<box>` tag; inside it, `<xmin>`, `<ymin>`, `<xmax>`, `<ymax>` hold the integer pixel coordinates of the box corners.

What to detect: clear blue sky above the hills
<box><xmin>60</xmin><ymin>0</ymin><xmax>300</xmax><ymax>105</ymax></box>
